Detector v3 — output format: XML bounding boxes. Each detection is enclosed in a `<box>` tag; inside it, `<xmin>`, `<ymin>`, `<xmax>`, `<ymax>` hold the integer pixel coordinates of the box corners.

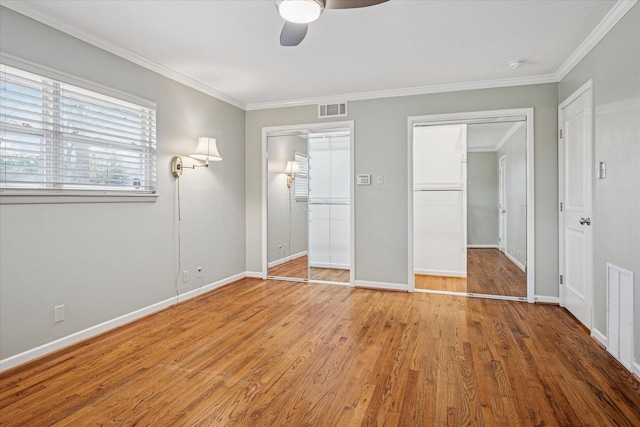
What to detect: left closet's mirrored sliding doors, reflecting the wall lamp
<box><xmin>267</xmin><ymin>130</ymin><xmax>351</xmax><ymax>283</ymax></box>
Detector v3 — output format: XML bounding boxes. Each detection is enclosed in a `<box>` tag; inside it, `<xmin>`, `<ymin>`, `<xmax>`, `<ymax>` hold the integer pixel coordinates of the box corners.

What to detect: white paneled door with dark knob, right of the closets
<box><xmin>558</xmin><ymin>81</ymin><xmax>593</xmax><ymax>329</ymax></box>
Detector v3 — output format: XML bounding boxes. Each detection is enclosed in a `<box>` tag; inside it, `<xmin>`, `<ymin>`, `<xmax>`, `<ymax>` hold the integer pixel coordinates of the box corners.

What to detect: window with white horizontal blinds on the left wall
<box><xmin>0</xmin><ymin>58</ymin><xmax>156</xmax><ymax>194</ymax></box>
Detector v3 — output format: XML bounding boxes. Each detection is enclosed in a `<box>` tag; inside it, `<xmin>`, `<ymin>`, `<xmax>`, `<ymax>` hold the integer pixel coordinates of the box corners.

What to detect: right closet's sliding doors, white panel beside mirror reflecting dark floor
<box><xmin>414</xmin><ymin>117</ymin><xmax>527</xmax><ymax>298</ymax></box>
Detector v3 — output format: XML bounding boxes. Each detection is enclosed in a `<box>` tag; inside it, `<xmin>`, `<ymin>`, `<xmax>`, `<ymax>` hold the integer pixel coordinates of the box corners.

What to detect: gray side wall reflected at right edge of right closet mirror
<box><xmin>497</xmin><ymin>122</ymin><xmax>527</xmax><ymax>266</ymax></box>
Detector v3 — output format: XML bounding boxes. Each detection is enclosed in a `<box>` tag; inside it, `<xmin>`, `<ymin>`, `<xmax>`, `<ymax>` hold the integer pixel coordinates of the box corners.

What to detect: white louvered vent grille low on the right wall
<box><xmin>607</xmin><ymin>263</ymin><xmax>634</xmax><ymax>371</ymax></box>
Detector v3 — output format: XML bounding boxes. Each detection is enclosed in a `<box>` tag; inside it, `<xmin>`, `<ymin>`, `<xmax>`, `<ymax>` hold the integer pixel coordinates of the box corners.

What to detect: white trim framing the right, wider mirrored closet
<box><xmin>407</xmin><ymin>108</ymin><xmax>535</xmax><ymax>303</ymax></box>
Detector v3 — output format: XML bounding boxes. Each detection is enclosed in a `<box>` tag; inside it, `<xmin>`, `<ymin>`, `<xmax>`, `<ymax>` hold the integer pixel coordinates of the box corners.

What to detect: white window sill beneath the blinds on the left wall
<box><xmin>0</xmin><ymin>190</ymin><xmax>158</xmax><ymax>205</ymax></box>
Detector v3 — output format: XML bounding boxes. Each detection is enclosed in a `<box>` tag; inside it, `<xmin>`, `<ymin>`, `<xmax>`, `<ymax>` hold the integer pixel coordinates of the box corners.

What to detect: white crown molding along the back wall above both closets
<box><xmin>246</xmin><ymin>74</ymin><xmax>558</xmax><ymax>111</ymax></box>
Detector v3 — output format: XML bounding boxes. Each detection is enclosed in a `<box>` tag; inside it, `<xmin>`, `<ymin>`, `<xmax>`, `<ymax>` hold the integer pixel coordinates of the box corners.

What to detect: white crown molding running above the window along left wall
<box><xmin>1</xmin><ymin>0</ymin><xmax>246</xmax><ymax>110</ymax></box>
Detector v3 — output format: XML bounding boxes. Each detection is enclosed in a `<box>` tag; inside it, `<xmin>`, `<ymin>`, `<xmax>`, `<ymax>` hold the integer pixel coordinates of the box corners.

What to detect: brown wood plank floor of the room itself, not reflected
<box><xmin>0</xmin><ymin>279</ymin><xmax>640</xmax><ymax>427</ymax></box>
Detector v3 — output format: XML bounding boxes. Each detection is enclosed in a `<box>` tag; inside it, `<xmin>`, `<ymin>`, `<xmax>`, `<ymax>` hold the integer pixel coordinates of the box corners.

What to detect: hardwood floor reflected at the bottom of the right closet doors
<box><xmin>415</xmin><ymin>248</ymin><xmax>527</xmax><ymax>297</ymax></box>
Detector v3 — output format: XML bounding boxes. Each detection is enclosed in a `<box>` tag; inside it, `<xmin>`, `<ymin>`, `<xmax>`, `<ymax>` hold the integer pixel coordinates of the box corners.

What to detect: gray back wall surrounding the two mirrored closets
<box><xmin>246</xmin><ymin>84</ymin><xmax>558</xmax><ymax>296</ymax></box>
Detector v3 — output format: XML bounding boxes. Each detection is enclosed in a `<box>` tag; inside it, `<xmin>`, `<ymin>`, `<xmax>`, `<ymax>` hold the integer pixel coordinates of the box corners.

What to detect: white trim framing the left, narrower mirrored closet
<box><xmin>260</xmin><ymin>120</ymin><xmax>356</xmax><ymax>286</ymax></box>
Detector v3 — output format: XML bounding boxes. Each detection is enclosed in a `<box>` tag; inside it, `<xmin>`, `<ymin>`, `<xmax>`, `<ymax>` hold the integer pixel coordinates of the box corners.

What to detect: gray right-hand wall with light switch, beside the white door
<box><xmin>559</xmin><ymin>4</ymin><xmax>640</xmax><ymax>361</ymax></box>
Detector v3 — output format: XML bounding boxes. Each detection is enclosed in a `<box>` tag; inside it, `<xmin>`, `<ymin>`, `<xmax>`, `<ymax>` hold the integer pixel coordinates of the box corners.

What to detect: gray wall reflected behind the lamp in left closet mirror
<box><xmin>267</xmin><ymin>135</ymin><xmax>307</xmax><ymax>262</ymax></box>
